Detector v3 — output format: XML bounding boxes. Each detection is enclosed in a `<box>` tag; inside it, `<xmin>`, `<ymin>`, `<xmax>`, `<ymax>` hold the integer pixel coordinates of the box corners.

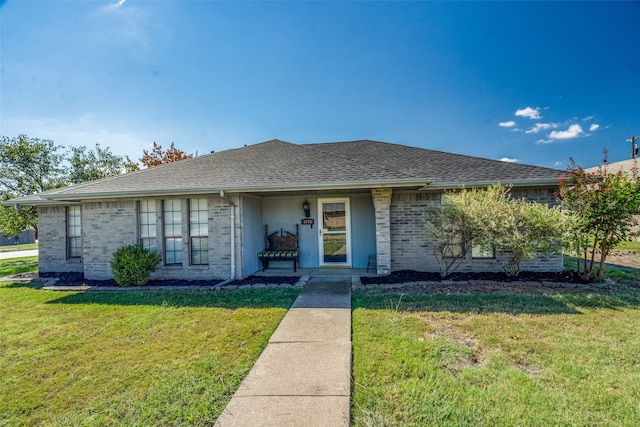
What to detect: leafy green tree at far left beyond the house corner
<box><xmin>0</xmin><ymin>135</ymin><xmax>65</xmax><ymax>236</ymax></box>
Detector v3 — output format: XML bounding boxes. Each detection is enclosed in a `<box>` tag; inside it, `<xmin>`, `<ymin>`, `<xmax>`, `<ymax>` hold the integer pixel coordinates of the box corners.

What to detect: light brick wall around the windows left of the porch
<box><xmin>38</xmin><ymin>196</ymin><xmax>242</xmax><ymax>280</ymax></box>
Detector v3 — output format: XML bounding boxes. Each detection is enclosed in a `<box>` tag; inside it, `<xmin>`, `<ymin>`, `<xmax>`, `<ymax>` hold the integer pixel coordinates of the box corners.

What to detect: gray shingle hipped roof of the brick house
<box><xmin>8</xmin><ymin>140</ymin><xmax>562</xmax><ymax>202</ymax></box>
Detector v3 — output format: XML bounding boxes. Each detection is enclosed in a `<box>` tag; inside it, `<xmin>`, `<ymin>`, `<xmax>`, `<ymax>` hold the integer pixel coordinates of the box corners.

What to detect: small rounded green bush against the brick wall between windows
<box><xmin>111</xmin><ymin>245</ymin><xmax>162</xmax><ymax>286</ymax></box>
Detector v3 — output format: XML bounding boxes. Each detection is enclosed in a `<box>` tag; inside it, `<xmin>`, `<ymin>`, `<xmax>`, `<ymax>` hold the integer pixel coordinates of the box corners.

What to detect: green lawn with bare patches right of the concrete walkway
<box><xmin>352</xmin><ymin>288</ymin><xmax>640</xmax><ymax>426</ymax></box>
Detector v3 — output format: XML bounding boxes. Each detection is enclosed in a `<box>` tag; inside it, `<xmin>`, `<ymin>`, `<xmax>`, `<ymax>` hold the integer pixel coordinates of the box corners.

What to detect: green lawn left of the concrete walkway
<box><xmin>0</xmin><ymin>282</ymin><xmax>298</xmax><ymax>426</ymax></box>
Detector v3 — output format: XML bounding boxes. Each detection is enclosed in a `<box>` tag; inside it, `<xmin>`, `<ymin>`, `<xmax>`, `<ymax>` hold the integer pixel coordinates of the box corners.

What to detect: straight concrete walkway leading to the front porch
<box><xmin>215</xmin><ymin>277</ymin><xmax>351</xmax><ymax>427</ymax></box>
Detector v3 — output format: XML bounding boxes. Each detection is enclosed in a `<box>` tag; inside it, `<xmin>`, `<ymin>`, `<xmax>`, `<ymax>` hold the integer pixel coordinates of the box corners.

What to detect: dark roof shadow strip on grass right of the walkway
<box><xmin>352</xmin><ymin>287</ymin><xmax>640</xmax><ymax>315</ymax></box>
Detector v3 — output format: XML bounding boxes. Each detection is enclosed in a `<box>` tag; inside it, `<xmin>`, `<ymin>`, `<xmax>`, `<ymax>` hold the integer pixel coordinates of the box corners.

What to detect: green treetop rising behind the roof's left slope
<box><xmin>67</xmin><ymin>144</ymin><xmax>125</xmax><ymax>184</ymax></box>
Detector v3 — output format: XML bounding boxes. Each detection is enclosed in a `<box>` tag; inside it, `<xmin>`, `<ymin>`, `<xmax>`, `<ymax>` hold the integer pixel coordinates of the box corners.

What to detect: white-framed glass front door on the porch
<box><xmin>318</xmin><ymin>198</ymin><xmax>351</xmax><ymax>267</ymax></box>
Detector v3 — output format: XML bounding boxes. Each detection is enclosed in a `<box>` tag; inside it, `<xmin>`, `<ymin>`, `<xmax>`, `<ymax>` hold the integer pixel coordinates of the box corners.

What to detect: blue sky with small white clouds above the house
<box><xmin>0</xmin><ymin>0</ymin><xmax>640</xmax><ymax>169</ymax></box>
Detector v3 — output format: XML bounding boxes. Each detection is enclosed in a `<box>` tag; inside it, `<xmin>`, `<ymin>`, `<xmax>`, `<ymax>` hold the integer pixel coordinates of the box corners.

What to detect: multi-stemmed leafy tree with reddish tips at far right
<box><xmin>559</xmin><ymin>159</ymin><xmax>640</xmax><ymax>281</ymax></box>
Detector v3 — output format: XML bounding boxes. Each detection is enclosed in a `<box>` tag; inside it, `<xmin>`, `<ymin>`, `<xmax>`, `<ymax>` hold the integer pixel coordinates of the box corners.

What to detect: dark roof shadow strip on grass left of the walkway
<box><xmin>48</xmin><ymin>288</ymin><xmax>300</xmax><ymax>309</ymax></box>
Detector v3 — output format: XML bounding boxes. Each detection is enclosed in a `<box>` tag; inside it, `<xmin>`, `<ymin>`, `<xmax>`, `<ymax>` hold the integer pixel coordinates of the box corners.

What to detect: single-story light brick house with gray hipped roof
<box><xmin>5</xmin><ymin>140</ymin><xmax>562</xmax><ymax>279</ymax></box>
